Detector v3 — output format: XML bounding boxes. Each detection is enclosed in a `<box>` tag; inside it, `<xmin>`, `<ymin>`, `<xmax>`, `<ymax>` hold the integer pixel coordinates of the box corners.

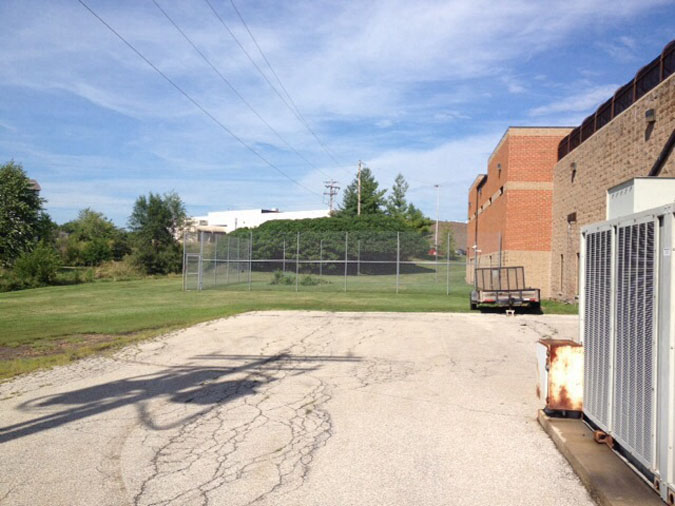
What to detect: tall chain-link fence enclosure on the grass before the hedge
<box><xmin>183</xmin><ymin>231</ymin><xmax>465</xmax><ymax>295</ymax></box>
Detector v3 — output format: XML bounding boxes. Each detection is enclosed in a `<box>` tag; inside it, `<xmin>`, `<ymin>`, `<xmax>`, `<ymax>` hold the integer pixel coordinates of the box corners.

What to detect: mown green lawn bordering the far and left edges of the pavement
<box><xmin>0</xmin><ymin>277</ymin><xmax>577</xmax><ymax>379</ymax></box>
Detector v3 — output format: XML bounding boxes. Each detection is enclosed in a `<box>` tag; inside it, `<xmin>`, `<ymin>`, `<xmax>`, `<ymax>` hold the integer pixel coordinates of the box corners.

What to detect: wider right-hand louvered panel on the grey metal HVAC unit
<box><xmin>613</xmin><ymin>221</ymin><xmax>655</xmax><ymax>469</ymax></box>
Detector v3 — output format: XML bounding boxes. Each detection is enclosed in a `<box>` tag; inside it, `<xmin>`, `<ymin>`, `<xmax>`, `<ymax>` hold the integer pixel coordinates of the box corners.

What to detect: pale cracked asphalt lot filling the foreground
<box><xmin>0</xmin><ymin>312</ymin><xmax>593</xmax><ymax>506</ymax></box>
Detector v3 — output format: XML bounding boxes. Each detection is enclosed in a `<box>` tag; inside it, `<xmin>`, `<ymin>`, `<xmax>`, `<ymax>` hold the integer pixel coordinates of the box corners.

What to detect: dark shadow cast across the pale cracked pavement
<box><xmin>0</xmin><ymin>353</ymin><xmax>361</xmax><ymax>444</ymax></box>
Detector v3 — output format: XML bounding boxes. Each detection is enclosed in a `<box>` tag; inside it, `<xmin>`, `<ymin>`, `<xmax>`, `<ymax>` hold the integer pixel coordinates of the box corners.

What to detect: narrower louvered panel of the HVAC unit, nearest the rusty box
<box><xmin>583</xmin><ymin>230</ymin><xmax>612</xmax><ymax>430</ymax></box>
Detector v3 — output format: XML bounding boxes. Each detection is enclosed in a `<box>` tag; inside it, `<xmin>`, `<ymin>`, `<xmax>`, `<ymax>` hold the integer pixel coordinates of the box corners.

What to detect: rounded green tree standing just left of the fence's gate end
<box><xmin>129</xmin><ymin>192</ymin><xmax>187</xmax><ymax>274</ymax></box>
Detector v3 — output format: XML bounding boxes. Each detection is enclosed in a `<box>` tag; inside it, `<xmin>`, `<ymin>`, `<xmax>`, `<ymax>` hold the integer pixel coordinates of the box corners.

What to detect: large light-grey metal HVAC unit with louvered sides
<box><xmin>579</xmin><ymin>179</ymin><xmax>675</xmax><ymax>504</ymax></box>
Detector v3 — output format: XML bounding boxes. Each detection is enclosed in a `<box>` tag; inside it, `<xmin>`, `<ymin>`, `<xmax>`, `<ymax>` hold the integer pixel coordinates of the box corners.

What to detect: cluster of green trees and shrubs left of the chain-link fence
<box><xmin>0</xmin><ymin>161</ymin><xmax>187</xmax><ymax>291</ymax></box>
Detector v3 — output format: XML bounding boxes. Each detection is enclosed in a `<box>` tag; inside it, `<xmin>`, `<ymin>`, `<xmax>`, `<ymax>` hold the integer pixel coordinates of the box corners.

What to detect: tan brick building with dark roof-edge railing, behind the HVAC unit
<box><xmin>550</xmin><ymin>42</ymin><xmax>675</xmax><ymax>300</ymax></box>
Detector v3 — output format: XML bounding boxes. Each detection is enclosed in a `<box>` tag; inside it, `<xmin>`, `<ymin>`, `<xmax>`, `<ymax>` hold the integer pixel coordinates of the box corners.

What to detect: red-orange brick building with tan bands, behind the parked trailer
<box><xmin>466</xmin><ymin>127</ymin><xmax>572</xmax><ymax>297</ymax></box>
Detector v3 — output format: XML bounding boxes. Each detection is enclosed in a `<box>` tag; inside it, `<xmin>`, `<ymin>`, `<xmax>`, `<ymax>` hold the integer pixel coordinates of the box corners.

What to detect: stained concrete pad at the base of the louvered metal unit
<box><xmin>538</xmin><ymin>411</ymin><xmax>664</xmax><ymax>506</ymax></box>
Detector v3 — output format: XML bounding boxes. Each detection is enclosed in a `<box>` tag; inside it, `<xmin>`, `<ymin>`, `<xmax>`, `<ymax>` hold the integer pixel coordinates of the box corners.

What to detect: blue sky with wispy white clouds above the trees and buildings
<box><xmin>0</xmin><ymin>0</ymin><xmax>675</xmax><ymax>225</ymax></box>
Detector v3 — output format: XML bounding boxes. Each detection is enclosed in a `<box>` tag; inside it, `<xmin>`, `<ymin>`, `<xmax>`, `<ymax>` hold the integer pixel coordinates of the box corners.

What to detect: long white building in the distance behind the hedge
<box><xmin>189</xmin><ymin>209</ymin><xmax>330</xmax><ymax>232</ymax></box>
